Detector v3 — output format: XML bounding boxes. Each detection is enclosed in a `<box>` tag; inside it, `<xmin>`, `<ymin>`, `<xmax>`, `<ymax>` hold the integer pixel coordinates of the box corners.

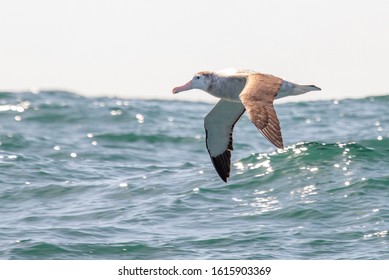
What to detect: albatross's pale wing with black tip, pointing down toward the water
<box><xmin>204</xmin><ymin>99</ymin><xmax>245</xmax><ymax>182</ymax></box>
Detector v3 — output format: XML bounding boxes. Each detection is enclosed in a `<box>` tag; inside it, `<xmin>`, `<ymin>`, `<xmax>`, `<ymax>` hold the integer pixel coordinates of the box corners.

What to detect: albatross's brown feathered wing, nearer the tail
<box><xmin>240</xmin><ymin>73</ymin><xmax>284</xmax><ymax>148</ymax></box>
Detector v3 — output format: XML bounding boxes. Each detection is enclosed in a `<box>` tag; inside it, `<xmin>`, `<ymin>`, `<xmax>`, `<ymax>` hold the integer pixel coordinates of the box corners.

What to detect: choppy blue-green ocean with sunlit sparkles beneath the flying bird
<box><xmin>0</xmin><ymin>91</ymin><xmax>389</xmax><ymax>260</ymax></box>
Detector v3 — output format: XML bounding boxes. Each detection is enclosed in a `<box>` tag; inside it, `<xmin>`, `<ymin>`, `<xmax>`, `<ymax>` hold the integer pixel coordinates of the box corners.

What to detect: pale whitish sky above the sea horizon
<box><xmin>0</xmin><ymin>0</ymin><xmax>389</xmax><ymax>100</ymax></box>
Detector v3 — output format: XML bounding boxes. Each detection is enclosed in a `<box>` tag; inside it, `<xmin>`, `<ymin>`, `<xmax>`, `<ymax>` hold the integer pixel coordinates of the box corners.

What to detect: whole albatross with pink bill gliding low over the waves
<box><xmin>173</xmin><ymin>69</ymin><xmax>320</xmax><ymax>182</ymax></box>
